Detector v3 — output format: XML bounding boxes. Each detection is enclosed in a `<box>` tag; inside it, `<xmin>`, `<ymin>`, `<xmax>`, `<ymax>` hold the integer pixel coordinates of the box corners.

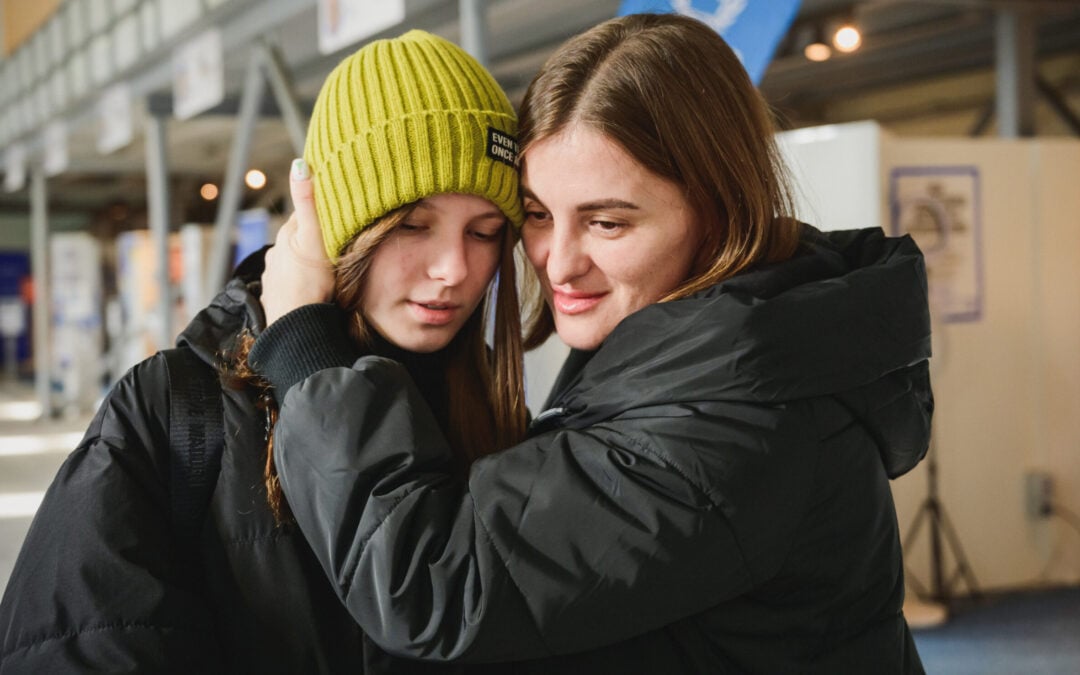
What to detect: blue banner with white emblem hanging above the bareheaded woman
<box><xmin>619</xmin><ymin>0</ymin><xmax>799</xmax><ymax>85</ymax></box>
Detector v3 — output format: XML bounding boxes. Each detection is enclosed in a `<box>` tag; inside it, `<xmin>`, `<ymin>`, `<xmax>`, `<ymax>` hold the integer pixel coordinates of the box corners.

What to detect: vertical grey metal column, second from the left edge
<box><xmin>146</xmin><ymin>112</ymin><xmax>174</xmax><ymax>349</ymax></box>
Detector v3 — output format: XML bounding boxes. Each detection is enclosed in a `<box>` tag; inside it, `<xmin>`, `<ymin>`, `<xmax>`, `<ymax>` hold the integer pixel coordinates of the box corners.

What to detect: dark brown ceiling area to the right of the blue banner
<box><xmin>761</xmin><ymin>0</ymin><xmax>1080</xmax><ymax>135</ymax></box>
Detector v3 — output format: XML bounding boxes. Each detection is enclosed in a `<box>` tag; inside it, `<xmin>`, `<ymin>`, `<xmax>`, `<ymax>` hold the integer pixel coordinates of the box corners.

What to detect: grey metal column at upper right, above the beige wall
<box><xmin>995</xmin><ymin>6</ymin><xmax>1036</xmax><ymax>138</ymax></box>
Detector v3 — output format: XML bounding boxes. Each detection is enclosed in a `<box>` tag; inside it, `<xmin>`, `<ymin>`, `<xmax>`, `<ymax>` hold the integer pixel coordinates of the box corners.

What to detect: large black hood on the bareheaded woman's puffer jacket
<box><xmin>544</xmin><ymin>226</ymin><xmax>931</xmax><ymax>474</ymax></box>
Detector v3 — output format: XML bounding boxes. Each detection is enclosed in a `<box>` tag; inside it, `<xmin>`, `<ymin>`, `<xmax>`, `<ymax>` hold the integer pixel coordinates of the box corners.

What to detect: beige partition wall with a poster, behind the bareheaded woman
<box><xmin>786</xmin><ymin>123</ymin><xmax>1080</xmax><ymax>592</ymax></box>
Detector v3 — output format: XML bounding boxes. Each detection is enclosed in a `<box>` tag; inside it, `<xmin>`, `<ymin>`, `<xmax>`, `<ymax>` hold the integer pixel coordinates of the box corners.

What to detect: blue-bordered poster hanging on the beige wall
<box><xmin>889</xmin><ymin>166</ymin><xmax>983</xmax><ymax>323</ymax></box>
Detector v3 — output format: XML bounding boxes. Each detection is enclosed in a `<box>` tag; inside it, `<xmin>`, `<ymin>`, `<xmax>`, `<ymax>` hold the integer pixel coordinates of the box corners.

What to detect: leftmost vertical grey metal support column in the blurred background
<box><xmin>30</xmin><ymin>165</ymin><xmax>53</xmax><ymax>418</ymax></box>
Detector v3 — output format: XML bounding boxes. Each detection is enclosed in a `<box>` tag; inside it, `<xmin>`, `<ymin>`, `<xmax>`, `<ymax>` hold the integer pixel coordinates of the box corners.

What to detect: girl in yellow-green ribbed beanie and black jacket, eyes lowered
<box><xmin>0</xmin><ymin>31</ymin><xmax>525</xmax><ymax>675</ymax></box>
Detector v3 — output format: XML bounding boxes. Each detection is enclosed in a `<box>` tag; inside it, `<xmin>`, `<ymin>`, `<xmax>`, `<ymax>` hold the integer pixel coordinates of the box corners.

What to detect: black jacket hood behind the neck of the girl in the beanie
<box><xmin>176</xmin><ymin>246</ymin><xmax>269</xmax><ymax>365</ymax></box>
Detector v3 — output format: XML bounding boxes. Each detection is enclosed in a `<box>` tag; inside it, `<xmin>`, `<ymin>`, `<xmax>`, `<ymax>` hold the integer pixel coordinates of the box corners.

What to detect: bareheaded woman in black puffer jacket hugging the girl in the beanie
<box><xmin>256</xmin><ymin>15</ymin><xmax>933</xmax><ymax>675</ymax></box>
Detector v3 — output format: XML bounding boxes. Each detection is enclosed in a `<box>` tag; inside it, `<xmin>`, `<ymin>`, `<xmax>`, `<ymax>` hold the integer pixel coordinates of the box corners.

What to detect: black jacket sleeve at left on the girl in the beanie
<box><xmin>0</xmin><ymin>355</ymin><xmax>218</xmax><ymax>674</ymax></box>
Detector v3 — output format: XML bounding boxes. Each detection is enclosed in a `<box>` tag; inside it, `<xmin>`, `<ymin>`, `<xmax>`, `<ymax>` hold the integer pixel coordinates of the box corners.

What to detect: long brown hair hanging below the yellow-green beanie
<box><xmin>227</xmin><ymin>204</ymin><xmax>526</xmax><ymax>523</ymax></box>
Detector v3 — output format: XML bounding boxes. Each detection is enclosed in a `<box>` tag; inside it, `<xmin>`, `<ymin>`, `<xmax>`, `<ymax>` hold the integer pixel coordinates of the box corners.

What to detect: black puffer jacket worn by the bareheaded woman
<box><xmin>250</xmin><ymin>227</ymin><xmax>933</xmax><ymax>674</ymax></box>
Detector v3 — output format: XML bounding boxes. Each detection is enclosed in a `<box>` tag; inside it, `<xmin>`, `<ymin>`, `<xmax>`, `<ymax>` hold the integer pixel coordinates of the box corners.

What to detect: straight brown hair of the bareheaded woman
<box><xmin>518</xmin><ymin>14</ymin><xmax>799</xmax><ymax>347</ymax></box>
